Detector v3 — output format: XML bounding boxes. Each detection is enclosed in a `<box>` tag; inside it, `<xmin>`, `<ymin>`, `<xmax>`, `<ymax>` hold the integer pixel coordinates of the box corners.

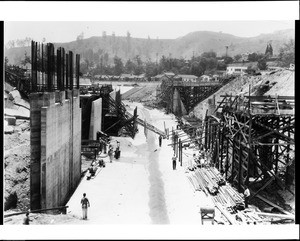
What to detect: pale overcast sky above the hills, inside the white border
<box><xmin>5</xmin><ymin>21</ymin><xmax>294</xmax><ymax>43</ymax></box>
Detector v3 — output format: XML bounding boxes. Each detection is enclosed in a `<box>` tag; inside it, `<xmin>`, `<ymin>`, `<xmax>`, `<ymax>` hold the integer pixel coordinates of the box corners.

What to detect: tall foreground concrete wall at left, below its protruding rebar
<box><xmin>30</xmin><ymin>90</ymin><xmax>81</xmax><ymax>210</ymax></box>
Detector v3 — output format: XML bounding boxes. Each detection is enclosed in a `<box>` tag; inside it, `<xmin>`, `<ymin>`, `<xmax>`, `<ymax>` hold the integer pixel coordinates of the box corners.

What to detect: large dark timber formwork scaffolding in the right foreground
<box><xmin>205</xmin><ymin>95</ymin><xmax>295</xmax><ymax>198</ymax></box>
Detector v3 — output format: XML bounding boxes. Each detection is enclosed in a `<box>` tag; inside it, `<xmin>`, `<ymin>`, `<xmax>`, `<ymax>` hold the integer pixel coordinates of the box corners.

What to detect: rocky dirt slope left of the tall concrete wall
<box><xmin>4</xmin><ymin>87</ymin><xmax>30</xmax><ymax>210</ymax></box>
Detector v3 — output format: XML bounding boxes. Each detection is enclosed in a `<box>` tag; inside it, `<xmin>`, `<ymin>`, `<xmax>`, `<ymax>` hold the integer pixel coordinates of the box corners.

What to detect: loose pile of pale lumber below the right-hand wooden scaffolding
<box><xmin>187</xmin><ymin>166</ymin><xmax>295</xmax><ymax>225</ymax></box>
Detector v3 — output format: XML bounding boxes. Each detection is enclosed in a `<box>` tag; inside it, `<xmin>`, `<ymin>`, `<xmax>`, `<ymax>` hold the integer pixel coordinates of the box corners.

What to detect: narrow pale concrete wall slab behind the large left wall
<box><xmin>89</xmin><ymin>98</ymin><xmax>102</xmax><ymax>140</ymax></box>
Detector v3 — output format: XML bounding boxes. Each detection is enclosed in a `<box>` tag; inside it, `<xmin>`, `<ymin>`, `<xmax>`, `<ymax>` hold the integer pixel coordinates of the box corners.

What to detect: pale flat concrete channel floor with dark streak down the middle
<box><xmin>67</xmin><ymin>102</ymin><xmax>211</xmax><ymax>225</ymax></box>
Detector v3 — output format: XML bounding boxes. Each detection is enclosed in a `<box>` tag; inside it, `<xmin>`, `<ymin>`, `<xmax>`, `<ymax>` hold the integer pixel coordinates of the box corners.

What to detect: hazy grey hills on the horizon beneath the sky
<box><xmin>5</xmin><ymin>29</ymin><xmax>295</xmax><ymax>64</ymax></box>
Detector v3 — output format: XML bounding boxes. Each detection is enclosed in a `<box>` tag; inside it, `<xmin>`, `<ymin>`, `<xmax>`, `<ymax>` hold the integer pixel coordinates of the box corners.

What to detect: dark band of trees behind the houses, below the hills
<box><xmin>80</xmin><ymin>51</ymin><xmax>237</xmax><ymax>77</ymax></box>
